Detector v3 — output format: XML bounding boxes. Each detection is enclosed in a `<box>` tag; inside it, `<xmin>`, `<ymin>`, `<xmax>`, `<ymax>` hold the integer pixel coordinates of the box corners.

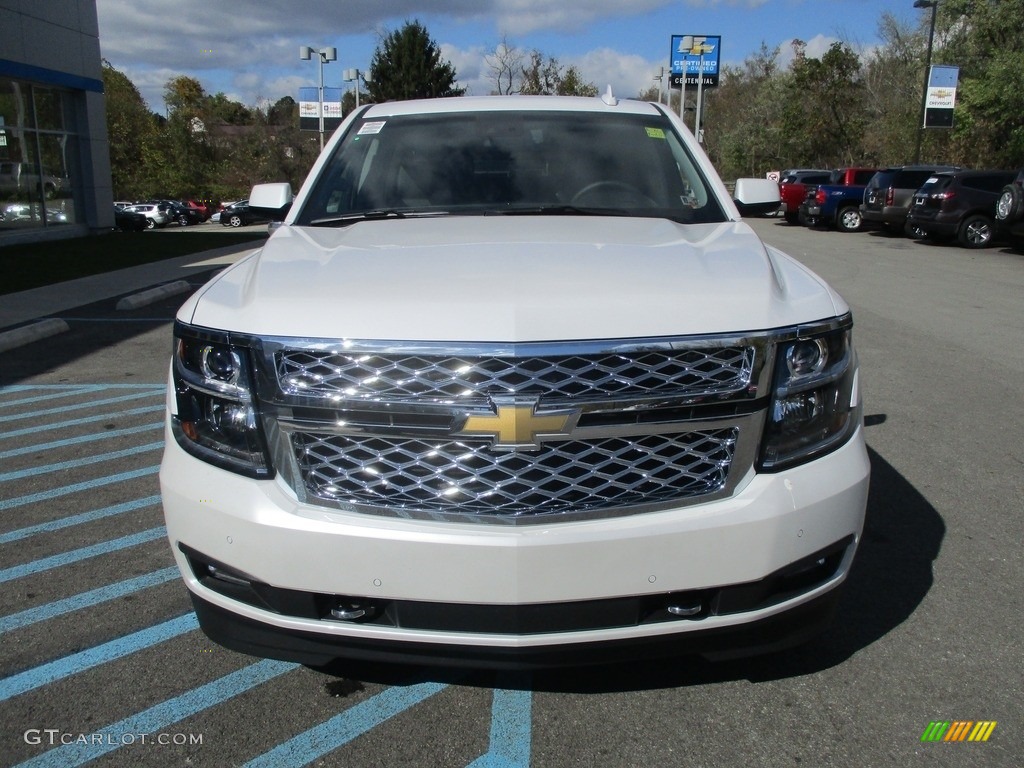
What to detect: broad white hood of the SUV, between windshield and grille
<box><xmin>178</xmin><ymin>216</ymin><xmax>846</xmax><ymax>342</ymax></box>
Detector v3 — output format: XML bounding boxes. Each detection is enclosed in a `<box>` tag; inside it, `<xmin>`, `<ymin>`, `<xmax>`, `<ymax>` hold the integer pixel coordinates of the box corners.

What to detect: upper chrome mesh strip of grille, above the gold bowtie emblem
<box><xmin>273</xmin><ymin>346</ymin><xmax>755</xmax><ymax>402</ymax></box>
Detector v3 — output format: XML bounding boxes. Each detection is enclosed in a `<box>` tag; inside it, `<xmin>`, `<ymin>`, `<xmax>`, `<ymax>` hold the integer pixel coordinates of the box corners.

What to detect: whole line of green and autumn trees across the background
<box><xmin>103</xmin><ymin>0</ymin><xmax>1024</xmax><ymax>200</ymax></box>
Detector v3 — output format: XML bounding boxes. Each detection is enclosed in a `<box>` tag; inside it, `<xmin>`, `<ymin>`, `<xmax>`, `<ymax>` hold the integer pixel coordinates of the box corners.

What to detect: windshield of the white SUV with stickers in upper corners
<box><xmin>296</xmin><ymin>111</ymin><xmax>725</xmax><ymax>225</ymax></box>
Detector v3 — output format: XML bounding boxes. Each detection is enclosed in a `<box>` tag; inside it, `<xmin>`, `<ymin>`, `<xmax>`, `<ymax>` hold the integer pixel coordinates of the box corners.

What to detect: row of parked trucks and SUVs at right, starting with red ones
<box><xmin>779</xmin><ymin>165</ymin><xmax>1024</xmax><ymax>248</ymax></box>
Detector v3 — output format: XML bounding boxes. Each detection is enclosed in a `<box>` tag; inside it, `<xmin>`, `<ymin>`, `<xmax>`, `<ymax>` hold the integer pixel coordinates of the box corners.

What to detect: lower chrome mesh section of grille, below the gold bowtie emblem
<box><xmin>291</xmin><ymin>427</ymin><xmax>738</xmax><ymax>518</ymax></box>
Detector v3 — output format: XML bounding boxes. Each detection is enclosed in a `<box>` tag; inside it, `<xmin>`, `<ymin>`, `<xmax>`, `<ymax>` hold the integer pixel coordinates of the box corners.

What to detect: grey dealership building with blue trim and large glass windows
<box><xmin>0</xmin><ymin>0</ymin><xmax>114</xmax><ymax>246</ymax></box>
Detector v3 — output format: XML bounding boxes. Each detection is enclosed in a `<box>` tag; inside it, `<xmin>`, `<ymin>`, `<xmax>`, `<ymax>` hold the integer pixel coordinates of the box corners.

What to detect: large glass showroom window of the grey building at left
<box><xmin>0</xmin><ymin>78</ymin><xmax>78</xmax><ymax>230</ymax></box>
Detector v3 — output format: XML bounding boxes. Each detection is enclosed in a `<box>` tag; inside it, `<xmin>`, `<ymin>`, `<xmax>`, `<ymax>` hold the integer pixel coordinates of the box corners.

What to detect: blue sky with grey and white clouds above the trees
<box><xmin>96</xmin><ymin>0</ymin><xmax>927</xmax><ymax>113</ymax></box>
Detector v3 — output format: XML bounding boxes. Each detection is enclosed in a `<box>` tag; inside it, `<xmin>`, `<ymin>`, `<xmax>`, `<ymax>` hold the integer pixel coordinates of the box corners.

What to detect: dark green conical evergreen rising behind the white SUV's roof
<box><xmin>367</xmin><ymin>22</ymin><xmax>466</xmax><ymax>102</ymax></box>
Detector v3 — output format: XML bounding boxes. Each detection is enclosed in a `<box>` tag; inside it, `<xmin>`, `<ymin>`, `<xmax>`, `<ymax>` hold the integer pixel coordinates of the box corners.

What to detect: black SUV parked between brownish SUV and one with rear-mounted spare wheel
<box><xmin>906</xmin><ymin>171</ymin><xmax>1014</xmax><ymax>248</ymax></box>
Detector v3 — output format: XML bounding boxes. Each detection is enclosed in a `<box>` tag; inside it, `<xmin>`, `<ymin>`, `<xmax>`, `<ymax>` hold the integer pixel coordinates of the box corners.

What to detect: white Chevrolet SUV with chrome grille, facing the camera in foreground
<box><xmin>160</xmin><ymin>89</ymin><xmax>869</xmax><ymax>668</ymax></box>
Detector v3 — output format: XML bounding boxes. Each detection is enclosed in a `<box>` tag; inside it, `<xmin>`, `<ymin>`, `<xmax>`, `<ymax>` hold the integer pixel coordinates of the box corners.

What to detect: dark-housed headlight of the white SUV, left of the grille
<box><xmin>171</xmin><ymin>324</ymin><xmax>272</xmax><ymax>478</ymax></box>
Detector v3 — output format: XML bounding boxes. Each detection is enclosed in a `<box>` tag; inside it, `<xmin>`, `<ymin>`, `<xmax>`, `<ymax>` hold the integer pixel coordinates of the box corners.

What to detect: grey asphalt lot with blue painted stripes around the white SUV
<box><xmin>0</xmin><ymin>219</ymin><xmax>1024</xmax><ymax>768</ymax></box>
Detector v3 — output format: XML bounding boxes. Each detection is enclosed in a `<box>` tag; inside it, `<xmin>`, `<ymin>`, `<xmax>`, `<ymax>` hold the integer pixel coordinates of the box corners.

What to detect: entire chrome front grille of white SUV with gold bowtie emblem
<box><xmin>256</xmin><ymin>335</ymin><xmax>774</xmax><ymax>524</ymax></box>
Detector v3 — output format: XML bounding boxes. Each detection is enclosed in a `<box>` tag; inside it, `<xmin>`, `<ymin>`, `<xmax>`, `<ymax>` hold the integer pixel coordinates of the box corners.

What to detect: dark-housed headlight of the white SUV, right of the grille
<box><xmin>761</xmin><ymin>323</ymin><xmax>861</xmax><ymax>471</ymax></box>
